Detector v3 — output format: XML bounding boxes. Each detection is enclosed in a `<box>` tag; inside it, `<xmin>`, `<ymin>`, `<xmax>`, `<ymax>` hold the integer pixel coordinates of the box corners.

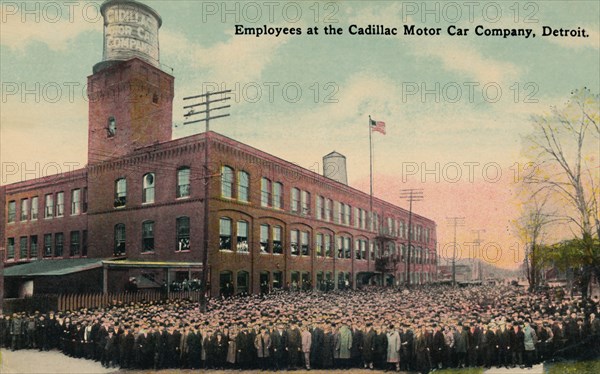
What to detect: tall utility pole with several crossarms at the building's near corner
<box><xmin>183</xmin><ymin>90</ymin><xmax>231</xmax><ymax>313</ymax></box>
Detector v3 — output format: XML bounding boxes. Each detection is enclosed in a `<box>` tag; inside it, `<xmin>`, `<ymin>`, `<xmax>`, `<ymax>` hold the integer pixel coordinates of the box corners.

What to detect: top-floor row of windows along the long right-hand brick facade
<box><xmin>221</xmin><ymin>166</ymin><xmax>430</xmax><ymax>243</ymax></box>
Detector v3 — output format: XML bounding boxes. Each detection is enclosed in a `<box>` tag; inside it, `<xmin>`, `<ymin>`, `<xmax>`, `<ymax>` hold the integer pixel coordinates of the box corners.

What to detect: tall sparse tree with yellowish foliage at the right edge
<box><xmin>524</xmin><ymin>88</ymin><xmax>600</xmax><ymax>296</ymax></box>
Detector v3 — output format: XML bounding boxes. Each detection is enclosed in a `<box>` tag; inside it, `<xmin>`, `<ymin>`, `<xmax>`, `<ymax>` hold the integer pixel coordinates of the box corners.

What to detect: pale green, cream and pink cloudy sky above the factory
<box><xmin>0</xmin><ymin>0</ymin><xmax>600</xmax><ymax>267</ymax></box>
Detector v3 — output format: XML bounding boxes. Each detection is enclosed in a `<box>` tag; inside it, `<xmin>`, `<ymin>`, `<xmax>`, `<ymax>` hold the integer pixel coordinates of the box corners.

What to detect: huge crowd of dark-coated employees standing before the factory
<box><xmin>0</xmin><ymin>285</ymin><xmax>600</xmax><ymax>373</ymax></box>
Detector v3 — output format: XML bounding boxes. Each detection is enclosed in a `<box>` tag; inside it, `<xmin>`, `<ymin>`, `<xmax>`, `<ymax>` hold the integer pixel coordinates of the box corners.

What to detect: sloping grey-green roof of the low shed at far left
<box><xmin>4</xmin><ymin>258</ymin><xmax>102</xmax><ymax>277</ymax></box>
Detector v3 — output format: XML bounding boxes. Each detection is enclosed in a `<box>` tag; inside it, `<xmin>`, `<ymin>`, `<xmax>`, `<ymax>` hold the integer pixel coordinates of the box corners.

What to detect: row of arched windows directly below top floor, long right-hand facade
<box><xmin>219</xmin><ymin>217</ymin><xmax>435</xmax><ymax>263</ymax></box>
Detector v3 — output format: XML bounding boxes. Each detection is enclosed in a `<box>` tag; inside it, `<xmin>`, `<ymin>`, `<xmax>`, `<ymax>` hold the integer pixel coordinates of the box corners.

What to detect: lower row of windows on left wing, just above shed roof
<box><xmin>6</xmin><ymin>230</ymin><xmax>88</xmax><ymax>260</ymax></box>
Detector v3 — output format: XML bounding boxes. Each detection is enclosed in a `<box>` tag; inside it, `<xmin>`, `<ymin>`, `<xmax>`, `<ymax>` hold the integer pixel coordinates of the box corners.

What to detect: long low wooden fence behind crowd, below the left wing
<box><xmin>4</xmin><ymin>290</ymin><xmax>201</xmax><ymax>313</ymax></box>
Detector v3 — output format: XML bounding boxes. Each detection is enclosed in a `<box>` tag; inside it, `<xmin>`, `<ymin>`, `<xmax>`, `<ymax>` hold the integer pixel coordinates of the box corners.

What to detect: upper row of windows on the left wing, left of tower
<box><xmin>7</xmin><ymin>188</ymin><xmax>87</xmax><ymax>223</ymax></box>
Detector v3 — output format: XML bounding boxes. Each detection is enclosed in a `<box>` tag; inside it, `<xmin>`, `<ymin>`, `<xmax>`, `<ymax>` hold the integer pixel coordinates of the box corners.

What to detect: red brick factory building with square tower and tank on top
<box><xmin>0</xmin><ymin>0</ymin><xmax>437</xmax><ymax>297</ymax></box>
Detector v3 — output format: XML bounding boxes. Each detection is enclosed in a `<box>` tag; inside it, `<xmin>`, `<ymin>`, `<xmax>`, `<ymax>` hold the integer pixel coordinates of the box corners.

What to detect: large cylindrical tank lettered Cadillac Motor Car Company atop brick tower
<box><xmin>94</xmin><ymin>0</ymin><xmax>162</xmax><ymax>73</ymax></box>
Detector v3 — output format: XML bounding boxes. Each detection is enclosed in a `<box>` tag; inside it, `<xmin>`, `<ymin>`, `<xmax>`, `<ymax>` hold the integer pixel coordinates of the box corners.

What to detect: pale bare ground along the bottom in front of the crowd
<box><xmin>0</xmin><ymin>349</ymin><xmax>544</xmax><ymax>374</ymax></box>
